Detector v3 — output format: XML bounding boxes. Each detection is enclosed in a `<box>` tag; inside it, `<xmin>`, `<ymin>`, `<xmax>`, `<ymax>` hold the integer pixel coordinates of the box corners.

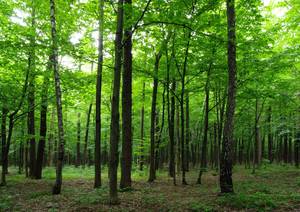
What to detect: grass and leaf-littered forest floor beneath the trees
<box><xmin>0</xmin><ymin>165</ymin><xmax>300</xmax><ymax>212</ymax></box>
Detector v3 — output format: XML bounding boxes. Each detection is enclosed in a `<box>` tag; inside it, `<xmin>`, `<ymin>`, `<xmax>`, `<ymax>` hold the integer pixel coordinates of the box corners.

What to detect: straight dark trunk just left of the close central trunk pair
<box><xmin>94</xmin><ymin>0</ymin><xmax>104</xmax><ymax>188</ymax></box>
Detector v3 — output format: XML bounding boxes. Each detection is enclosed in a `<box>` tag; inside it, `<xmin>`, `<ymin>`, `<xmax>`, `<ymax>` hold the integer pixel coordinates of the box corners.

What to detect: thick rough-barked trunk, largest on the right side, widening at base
<box><xmin>220</xmin><ymin>0</ymin><xmax>236</xmax><ymax>193</ymax></box>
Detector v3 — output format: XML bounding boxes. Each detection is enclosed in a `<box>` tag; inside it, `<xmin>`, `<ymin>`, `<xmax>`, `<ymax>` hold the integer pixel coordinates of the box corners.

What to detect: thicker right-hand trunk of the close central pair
<box><xmin>120</xmin><ymin>0</ymin><xmax>132</xmax><ymax>189</ymax></box>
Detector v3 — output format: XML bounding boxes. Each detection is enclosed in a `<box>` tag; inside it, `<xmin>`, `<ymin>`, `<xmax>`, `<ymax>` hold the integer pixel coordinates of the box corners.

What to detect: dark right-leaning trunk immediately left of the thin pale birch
<box><xmin>35</xmin><ymin>70</ymin><xmax>51</xmax><ymax>179</ymax></box>
